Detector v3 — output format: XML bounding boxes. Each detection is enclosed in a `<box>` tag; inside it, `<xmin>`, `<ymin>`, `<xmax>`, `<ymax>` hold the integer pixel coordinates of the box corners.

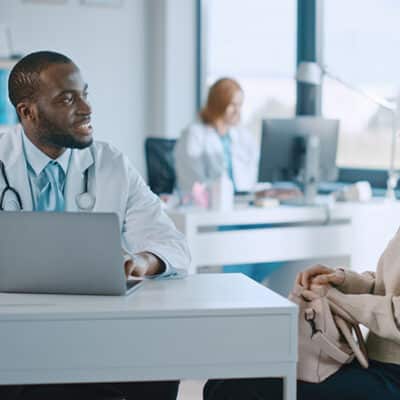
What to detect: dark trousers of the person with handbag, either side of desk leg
<box><xmin>203</xmin><ymin>361</ymin><xmax>400</xmax><ymax>400</ymax></box>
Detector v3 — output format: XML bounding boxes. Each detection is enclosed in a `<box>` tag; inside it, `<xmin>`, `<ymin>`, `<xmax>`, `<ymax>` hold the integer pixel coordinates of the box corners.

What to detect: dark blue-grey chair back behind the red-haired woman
<box><xmin>145</xmin><ymin>138</ymin><xmax>176</xmax><ymax>194</ymax></box>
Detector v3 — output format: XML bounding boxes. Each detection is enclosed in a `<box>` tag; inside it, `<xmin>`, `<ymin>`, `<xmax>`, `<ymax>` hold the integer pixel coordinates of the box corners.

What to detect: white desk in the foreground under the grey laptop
<box><xmin>0</xmin><ymin>274</ymin><xmax>297</xmax><ymax>400</ymax></box>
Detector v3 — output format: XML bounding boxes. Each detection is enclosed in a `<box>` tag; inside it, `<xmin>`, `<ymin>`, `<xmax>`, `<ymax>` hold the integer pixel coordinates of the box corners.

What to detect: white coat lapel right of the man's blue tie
<box><xmin>64</xmin><ymin>148</ymin><xmax>94</xmax><ymax>211</ymax></box>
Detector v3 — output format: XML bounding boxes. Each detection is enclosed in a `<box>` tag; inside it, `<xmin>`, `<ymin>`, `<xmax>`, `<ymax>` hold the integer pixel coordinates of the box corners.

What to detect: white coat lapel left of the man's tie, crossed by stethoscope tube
<box><xmin>0</xmin><ymin>127</ymin><xmax>33</xmax><ymax>211</ymax></box>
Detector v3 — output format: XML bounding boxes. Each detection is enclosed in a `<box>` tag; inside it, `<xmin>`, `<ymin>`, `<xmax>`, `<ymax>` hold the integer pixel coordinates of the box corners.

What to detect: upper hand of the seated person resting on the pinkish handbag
<box><xmin>296</xmin><ymin>264</ymin><xmax>345</xmax><ymax>289</ymax></box>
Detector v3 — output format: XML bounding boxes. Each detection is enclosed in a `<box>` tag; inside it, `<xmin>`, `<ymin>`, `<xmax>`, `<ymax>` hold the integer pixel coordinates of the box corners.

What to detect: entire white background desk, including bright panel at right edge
<box><xmin>168</xmin><ymin>199</ymin><xmax>400</xmax><ymax>272</ymax></box>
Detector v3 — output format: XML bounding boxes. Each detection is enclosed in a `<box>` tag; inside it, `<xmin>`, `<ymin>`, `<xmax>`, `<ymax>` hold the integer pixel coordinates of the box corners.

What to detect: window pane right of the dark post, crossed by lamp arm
<box><xmin>322</xmin><ymin>0</ymin><xmax>400</xmax><ymax>169</ymax></box>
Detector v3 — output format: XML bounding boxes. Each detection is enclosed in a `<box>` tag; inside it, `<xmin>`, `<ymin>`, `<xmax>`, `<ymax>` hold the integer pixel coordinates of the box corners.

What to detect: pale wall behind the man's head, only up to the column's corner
<box><xmin>0</xmin><ymin>0</ymin><xmax>145</xmax><ymax>172</ymax></box>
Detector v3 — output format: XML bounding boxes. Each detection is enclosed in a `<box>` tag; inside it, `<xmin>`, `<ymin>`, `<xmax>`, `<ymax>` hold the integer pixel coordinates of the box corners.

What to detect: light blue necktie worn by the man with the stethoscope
<box><xmin>36</xmin><ymin>161</ymin><xmax>64</xmax><ymax>212</ymax></box>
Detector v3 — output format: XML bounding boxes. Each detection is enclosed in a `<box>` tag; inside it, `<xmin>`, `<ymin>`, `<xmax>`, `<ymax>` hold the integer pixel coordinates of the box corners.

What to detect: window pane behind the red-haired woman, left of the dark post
<box><xmin>204</xmin><ymin>0</ymin><xmax>297</xmax><ymax>138</ymax></box>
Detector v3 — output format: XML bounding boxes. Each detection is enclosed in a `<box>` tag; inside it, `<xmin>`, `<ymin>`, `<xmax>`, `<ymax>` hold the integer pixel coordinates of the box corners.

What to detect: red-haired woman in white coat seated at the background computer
<box><xmin>175</xmin><ymin>78</ymin><xmax>258</xmax><ymax>192</ymax></box>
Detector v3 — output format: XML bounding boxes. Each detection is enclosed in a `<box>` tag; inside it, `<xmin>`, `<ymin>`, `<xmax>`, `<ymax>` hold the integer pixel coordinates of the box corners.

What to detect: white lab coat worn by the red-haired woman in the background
<box><xmin>175</xmin><ymin>122</ymin><xmax>259</xmax><ymax>192</ymax></box>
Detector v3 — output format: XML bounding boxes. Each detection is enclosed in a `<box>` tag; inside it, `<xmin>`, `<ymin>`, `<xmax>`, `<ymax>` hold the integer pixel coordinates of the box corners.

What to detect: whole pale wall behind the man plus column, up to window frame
<box><xmin>0</xmin><ymin>0</ymin><xmax>196</xmax><ymax>175</ymax></box>
